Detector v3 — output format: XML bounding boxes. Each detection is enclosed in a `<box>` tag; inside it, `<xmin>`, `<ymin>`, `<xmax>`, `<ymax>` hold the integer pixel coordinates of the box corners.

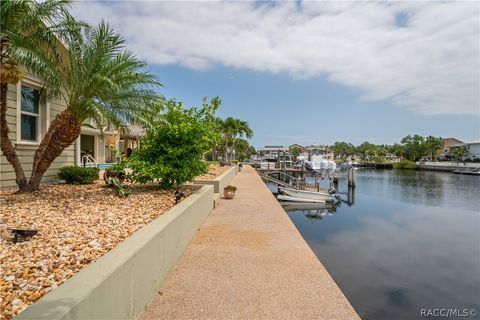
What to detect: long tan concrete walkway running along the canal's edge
<box><xmin>145</xmin><ymin>166</ymin><xmax>359</xmax><ymax>320</ymax></box>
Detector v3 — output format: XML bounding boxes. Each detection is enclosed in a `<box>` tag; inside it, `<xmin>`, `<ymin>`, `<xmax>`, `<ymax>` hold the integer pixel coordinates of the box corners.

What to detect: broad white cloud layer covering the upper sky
<box><xmin>74</xmin><ymin>1</ymin><xmax>480</xmax><ymax>115</ymax></box>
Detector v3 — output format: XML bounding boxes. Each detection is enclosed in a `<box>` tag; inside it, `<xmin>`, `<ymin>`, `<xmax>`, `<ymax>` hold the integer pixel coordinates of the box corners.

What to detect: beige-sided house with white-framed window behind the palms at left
<box><xmin>0</xmin><ymin>71</ymin><xmax>128</xmax><ymax>188</ymax></box>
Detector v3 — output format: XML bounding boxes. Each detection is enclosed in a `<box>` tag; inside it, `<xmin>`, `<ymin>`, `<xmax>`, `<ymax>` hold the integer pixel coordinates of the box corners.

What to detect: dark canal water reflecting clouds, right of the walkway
<box><xmin>272</xmin><ymin>170</ymin><xmax>480</xmax><ymax>320</ymax></box>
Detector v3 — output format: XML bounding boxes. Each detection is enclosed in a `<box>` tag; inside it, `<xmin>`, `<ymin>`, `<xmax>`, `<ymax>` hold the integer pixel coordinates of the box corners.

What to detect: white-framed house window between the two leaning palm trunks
<box><xmin>20</xmin><ymin>85</ymin><xmax>40</xmax><ymax>141</ymax></box>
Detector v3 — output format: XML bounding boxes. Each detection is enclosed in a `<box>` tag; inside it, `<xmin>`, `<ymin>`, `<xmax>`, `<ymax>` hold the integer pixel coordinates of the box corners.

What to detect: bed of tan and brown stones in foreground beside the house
<box><xmin>0</xmin><ymin>181</ymin><xmax>200</xmax><ymax>320</ymax></box>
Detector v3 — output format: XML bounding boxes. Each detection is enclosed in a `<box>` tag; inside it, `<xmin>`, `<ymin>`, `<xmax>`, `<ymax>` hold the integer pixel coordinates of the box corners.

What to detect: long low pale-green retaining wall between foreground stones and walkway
<box><xmin>15</xmin><ymin>186</ymin><xmax>213</xmax><ymax>320</ymax></box>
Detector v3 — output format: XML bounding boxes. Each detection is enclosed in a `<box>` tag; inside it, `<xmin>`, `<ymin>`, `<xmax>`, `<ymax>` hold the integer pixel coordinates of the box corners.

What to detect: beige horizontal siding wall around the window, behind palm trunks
<box><xmin>0</xmin><ymin>76</ymin><xmax>75</xmax><ymax>188</ymax></box>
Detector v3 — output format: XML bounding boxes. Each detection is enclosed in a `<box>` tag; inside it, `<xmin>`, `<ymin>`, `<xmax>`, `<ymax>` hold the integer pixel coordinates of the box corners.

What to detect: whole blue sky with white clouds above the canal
<box><xmin>73</xmin><ymin>1</ymin><xmax>480</xmax><ymax>147</ymax></box>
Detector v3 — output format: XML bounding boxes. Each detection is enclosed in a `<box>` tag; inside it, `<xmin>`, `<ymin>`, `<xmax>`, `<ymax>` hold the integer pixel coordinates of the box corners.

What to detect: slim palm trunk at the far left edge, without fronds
<box><xmin>0</xmin><ymin>82</ymin><xmax>27</xmax><ymax>192</ymax></box>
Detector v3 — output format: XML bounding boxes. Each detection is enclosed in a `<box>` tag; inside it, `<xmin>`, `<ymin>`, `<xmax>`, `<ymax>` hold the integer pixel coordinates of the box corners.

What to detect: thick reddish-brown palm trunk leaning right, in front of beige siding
<box><xmin>28</xmin><ymin>109</ymin><xmax>81</xmax><ymax>191</ymax></box>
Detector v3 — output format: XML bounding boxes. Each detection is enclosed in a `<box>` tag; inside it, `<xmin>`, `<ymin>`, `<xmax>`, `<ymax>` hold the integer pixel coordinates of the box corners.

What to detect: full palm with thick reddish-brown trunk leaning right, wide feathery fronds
<box><xmin>2</xmin><ymin>4</ymin><xmax>160</xmax><ymax>191</ymax></box>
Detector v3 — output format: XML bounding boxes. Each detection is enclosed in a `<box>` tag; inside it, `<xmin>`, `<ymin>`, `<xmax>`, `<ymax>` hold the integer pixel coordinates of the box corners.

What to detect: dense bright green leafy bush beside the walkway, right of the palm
<box><xmin>128</xmin><ymin>99</ymin><xmax>220</xmax><ymax>188</ymax></box>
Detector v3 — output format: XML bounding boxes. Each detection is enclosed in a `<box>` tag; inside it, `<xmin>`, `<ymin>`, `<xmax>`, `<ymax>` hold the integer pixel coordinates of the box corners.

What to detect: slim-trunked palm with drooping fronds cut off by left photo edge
<box><xmin>0</xmin><ymin>0</ymin><xmax>70</xmax><ymax>190</ymax></box>
